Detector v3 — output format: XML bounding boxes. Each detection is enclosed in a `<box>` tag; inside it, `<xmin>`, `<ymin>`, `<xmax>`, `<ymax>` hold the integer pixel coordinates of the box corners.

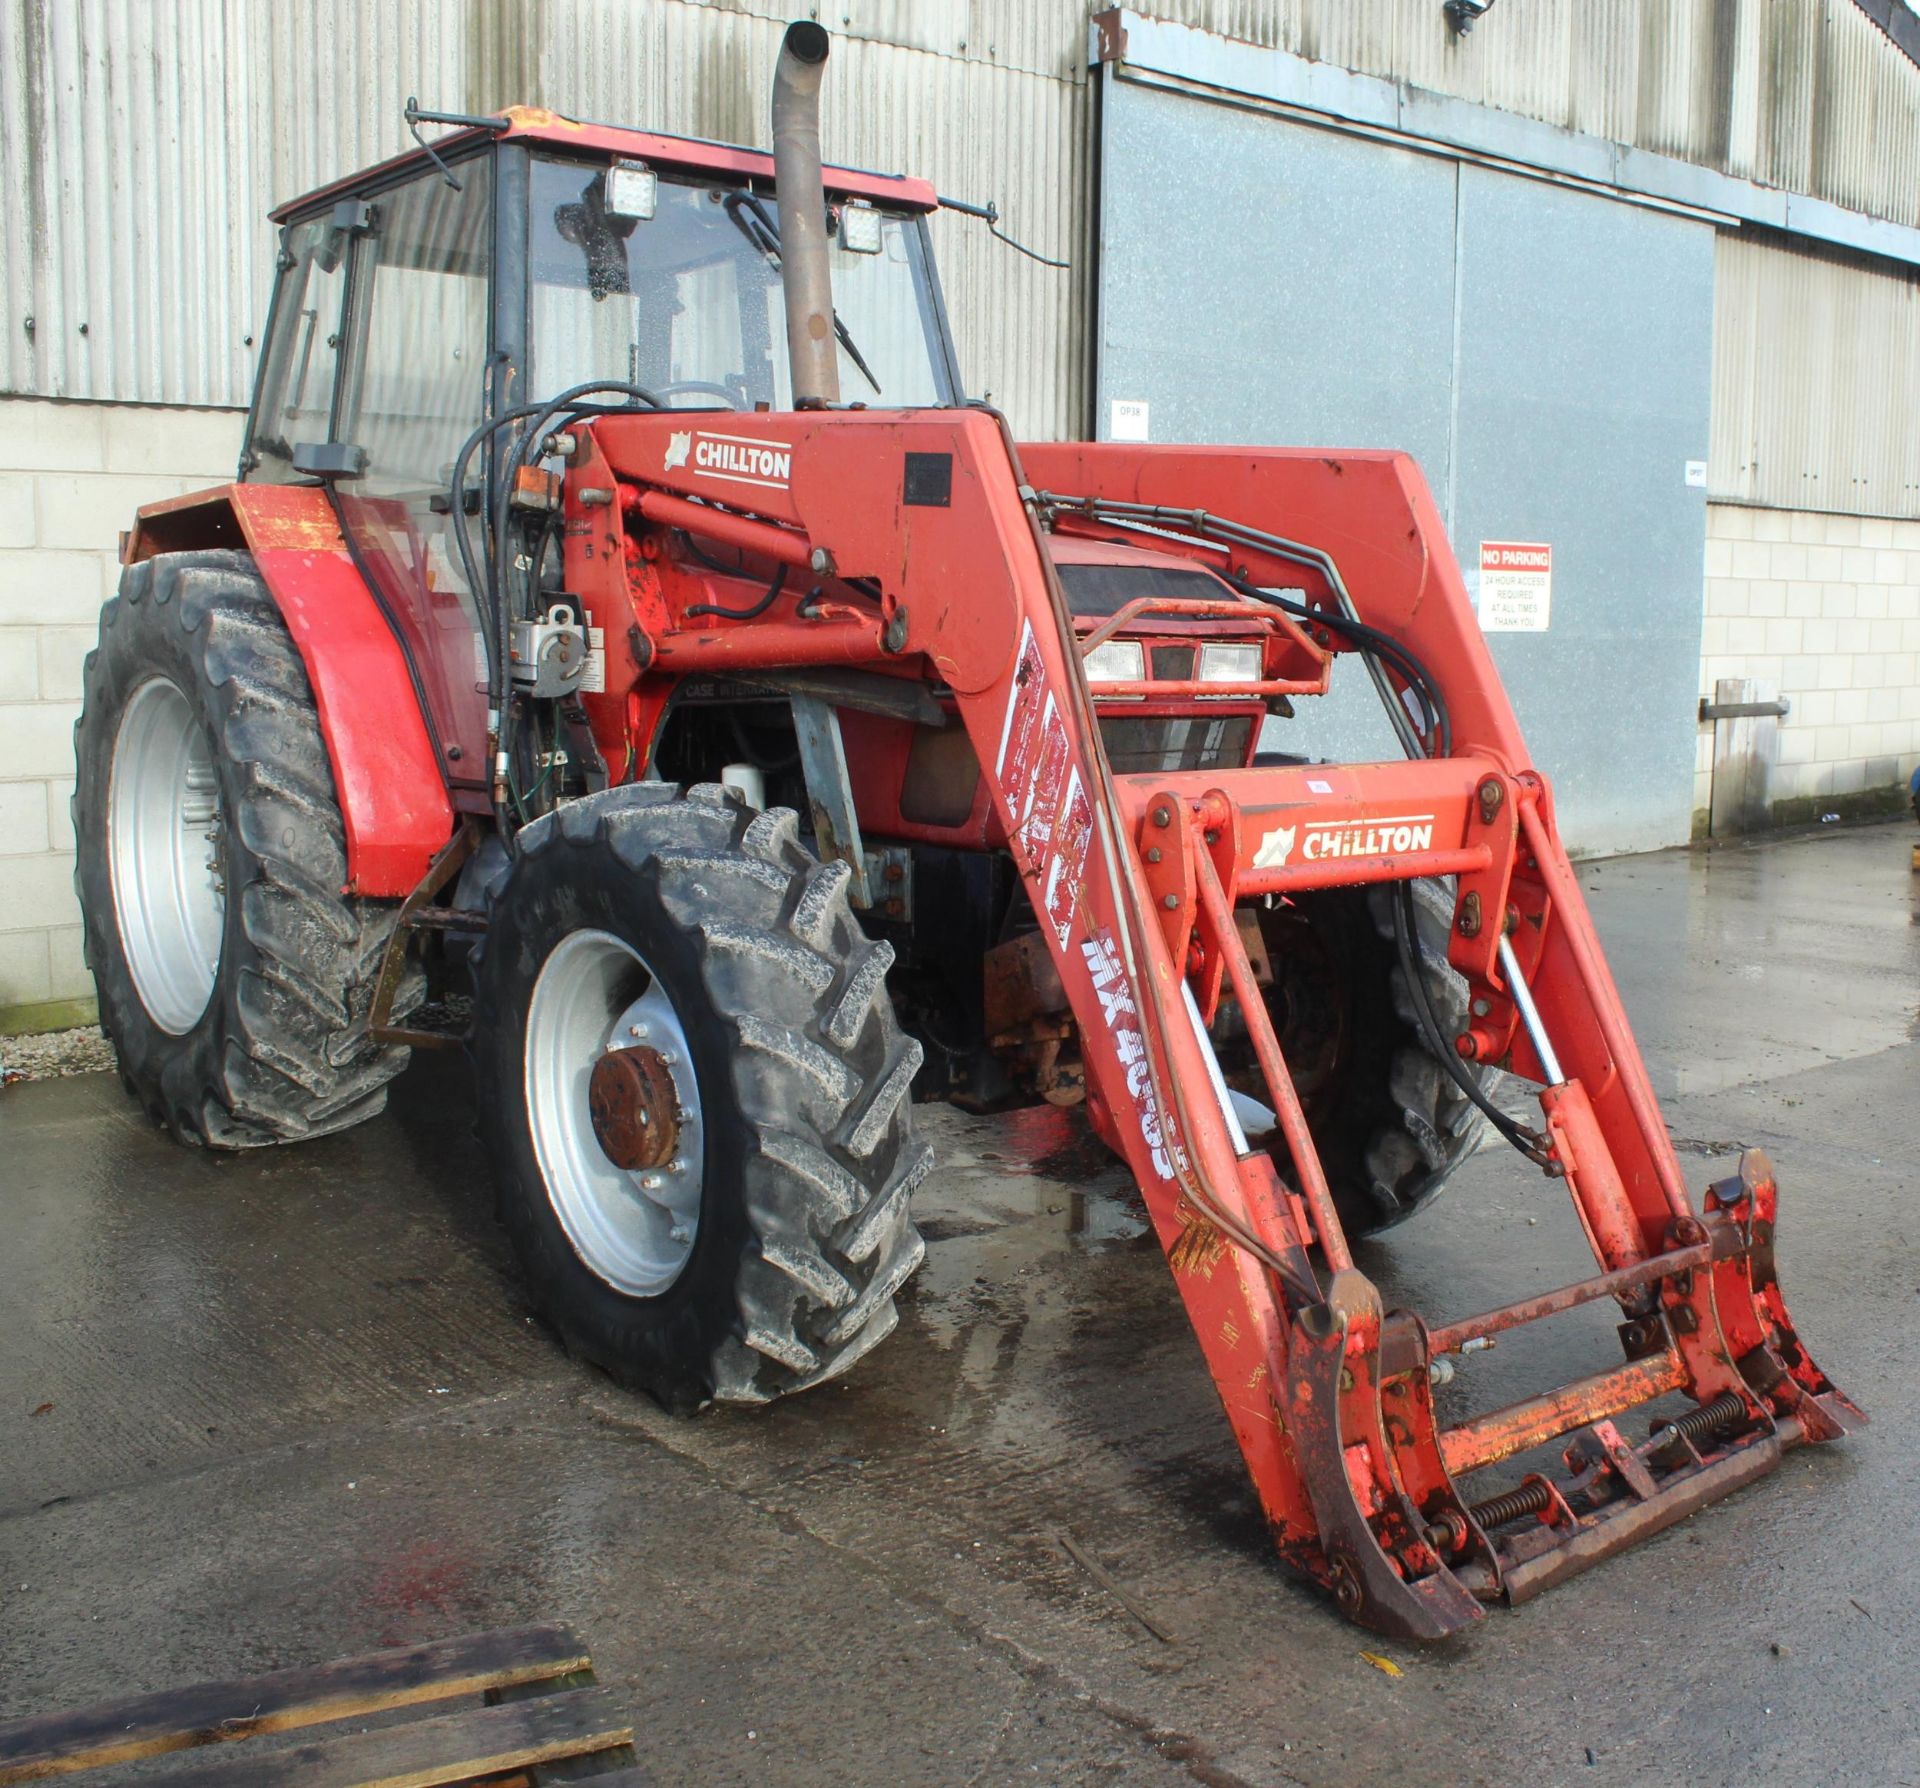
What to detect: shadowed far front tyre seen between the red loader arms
<box><xmin>1261</xmin><ymin>880</ymin><xmax>1484</xmax><ymax>1239</ymax></box>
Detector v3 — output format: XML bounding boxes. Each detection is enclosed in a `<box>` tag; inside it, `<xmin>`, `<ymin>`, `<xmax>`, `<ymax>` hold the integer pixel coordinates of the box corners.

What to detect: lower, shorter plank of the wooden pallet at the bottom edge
<box><xmin>167</xmin><ymin>1688</ymin><xmax>634</xmax><ymax>1788</ymax></box>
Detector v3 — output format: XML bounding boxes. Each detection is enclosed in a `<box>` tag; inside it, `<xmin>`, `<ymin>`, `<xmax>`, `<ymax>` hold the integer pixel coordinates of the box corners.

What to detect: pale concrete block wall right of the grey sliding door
<box><xmin>1693</xmin><ymin>503</ymin><xmax>1920</xmax><ymax>835</ymax></box>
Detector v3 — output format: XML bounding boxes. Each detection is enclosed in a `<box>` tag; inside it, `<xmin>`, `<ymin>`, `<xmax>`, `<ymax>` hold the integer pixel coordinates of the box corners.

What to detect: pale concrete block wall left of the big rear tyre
<box><xmin>0</xmin><ymin>398</ymin><xmax>244</xmax><ymax>1031</ymax></box>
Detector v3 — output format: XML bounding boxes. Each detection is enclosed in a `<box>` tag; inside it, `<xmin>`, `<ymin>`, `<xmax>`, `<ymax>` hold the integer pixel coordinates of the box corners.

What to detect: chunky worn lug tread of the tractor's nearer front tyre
<box><xmin>474</xmin><ymin>784</ymin><xmax>931</xmax><ymax>1406</ymax></box>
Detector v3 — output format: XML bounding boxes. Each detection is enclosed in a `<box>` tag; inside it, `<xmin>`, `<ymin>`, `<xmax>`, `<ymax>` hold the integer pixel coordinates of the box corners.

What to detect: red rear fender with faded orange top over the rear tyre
<box><xmin>123</xmin><ymin>484</ymin><xmax>453</xmax><ymax>899</ymax></box>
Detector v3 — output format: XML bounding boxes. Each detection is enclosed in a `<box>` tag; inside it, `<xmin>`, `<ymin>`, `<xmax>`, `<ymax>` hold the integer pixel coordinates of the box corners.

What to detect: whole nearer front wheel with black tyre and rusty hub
<box><xmin>468</xmin><ymin>784</ymin><xmax>933</xmax><ymax>1413</ymax></box>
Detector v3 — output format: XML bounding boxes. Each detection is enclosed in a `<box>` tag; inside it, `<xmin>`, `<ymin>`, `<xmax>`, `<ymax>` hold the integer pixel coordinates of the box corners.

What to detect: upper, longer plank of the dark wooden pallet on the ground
<box><xmin>0</xmin><ymin>1625</ymin><xmax>591</xmax><ymax>1784</ymax></box>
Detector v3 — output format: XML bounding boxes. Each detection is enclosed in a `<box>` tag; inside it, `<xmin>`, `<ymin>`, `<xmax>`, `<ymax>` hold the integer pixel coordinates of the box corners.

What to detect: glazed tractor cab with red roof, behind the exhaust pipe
<box><xmin>240</xmin><ymin>108</ymin><xmax>960</xmax><ymax>793</ymax></box>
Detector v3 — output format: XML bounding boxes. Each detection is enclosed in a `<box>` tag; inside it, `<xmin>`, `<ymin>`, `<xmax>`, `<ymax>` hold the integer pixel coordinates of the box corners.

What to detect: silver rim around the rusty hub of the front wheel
<box><xmin>526</xmin><ymin>931</ymin><xmax>705</xmax><ymax>1298</ymax></box>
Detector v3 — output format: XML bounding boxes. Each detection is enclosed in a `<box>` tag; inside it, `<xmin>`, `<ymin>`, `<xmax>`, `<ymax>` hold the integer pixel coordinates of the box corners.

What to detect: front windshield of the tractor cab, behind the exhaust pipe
<box><xmin>528</xmin><ymin>157</ymin><xmax>954</xmax><ymax>409</ymax></box>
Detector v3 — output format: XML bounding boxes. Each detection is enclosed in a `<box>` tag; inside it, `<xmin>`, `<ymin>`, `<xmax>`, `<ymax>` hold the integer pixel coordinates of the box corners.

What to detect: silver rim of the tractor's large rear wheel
<box><xmin>108</xmin><ymin>676</ymin><xmax>227</xmax><ymax>1037</ymax></box>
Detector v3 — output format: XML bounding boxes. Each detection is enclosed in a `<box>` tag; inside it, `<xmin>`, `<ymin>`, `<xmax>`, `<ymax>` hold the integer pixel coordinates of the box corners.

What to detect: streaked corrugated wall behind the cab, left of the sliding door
<box><xmin>0</xmin><ymin>0</ymin><xmax>1089</xmax><ymax>434</ymax></box>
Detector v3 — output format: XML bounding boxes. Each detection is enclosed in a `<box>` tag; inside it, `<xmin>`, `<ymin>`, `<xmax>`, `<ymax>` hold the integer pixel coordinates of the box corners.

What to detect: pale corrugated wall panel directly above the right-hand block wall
<box><xmin>1709</xmin><ymin>234</ymin><xmax>1920</xmax><ymax>517</ymax></box>
